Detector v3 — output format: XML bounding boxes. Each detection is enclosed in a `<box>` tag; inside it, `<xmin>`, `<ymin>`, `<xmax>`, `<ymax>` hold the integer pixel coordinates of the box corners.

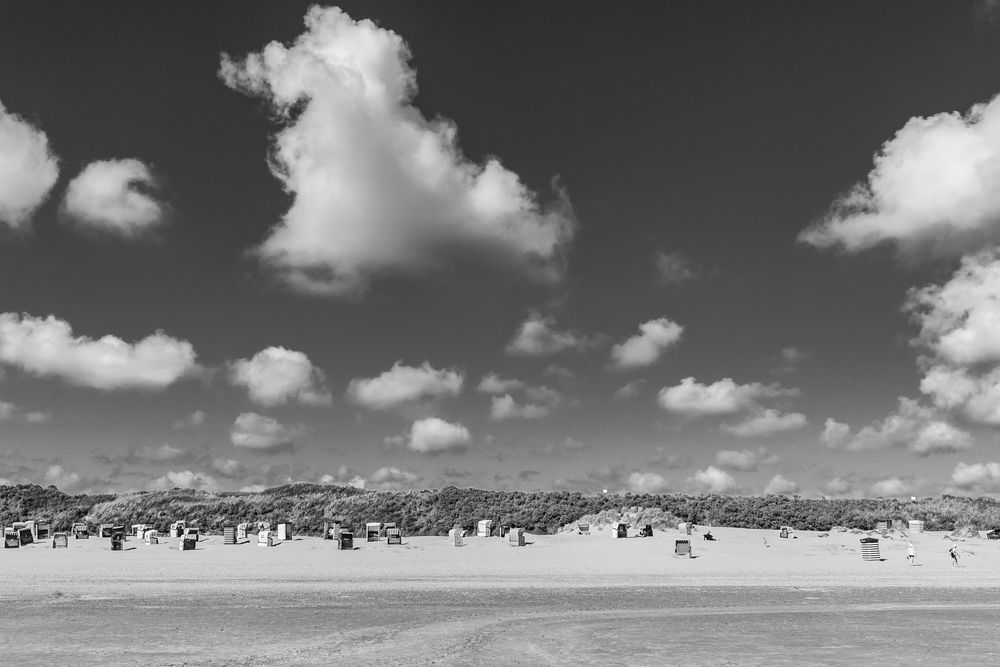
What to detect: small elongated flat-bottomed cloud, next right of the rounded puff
<box><xmin>347</xmin><ymin>361</ymin><xmax>465</xmax><ymax>410</ymax></box>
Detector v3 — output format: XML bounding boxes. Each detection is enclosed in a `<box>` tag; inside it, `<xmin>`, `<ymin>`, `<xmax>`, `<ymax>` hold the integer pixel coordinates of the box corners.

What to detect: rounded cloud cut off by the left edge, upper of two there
<box><xmin>0</xmin><ymin>103</ymin><xmax>59</xmax><ymax>228</ymax></box>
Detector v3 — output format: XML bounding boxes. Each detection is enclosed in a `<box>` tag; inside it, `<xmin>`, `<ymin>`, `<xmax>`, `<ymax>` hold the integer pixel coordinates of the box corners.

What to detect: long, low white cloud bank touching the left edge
<box><xmin>0</xmin><ymin>313</ymin><xmax>199</xmax><ymax>390</ymax></box>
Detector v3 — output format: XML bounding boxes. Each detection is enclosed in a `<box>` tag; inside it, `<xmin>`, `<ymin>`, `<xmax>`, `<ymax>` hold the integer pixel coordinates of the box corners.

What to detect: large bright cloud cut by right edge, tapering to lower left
<box><xmin>799</xmin><ymin>98</ymin><xmax>1000</xmax><ymax>254</ymax></box>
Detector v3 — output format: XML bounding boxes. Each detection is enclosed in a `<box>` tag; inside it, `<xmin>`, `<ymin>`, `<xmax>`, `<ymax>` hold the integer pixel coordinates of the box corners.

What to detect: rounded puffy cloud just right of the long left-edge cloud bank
<box><xmin>229</xmin><ymin>347</ymin><xmax>333</xmax><ymax>407</ymax></box>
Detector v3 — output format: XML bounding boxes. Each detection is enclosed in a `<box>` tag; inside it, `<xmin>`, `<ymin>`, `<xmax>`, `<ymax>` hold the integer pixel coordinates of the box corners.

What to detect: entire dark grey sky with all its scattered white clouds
<box><xmin>0</xmin><ymin>0</ymin><xmax>1000</xmax><ymax>497</ymax></box>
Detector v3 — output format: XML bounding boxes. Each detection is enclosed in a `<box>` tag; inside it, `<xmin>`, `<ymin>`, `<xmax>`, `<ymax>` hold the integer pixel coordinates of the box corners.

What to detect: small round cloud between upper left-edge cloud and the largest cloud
<box><xmin>63</xmin><ymin>159</ymin><xmax>164</xmax><ymax>238</ymax></box>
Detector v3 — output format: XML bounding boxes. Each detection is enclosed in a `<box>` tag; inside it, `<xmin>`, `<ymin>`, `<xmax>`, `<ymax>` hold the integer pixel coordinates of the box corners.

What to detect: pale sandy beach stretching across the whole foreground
<box><xmin>0</xmin><ymin>528</ymin><xmax>1000</xmax><ymax>665</ymax></box>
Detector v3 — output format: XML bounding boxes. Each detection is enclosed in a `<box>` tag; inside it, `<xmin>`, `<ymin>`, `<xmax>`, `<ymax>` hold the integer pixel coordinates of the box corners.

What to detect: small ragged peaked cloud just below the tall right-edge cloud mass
<box><xmin>846</xmin><ymin>398</ymin><xmax>972</xmax><ymax>456</ymax></box>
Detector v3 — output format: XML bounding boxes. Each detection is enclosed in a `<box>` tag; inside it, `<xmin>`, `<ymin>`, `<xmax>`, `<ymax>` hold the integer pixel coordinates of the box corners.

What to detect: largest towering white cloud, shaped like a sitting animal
<box><xmin>219</xmin><ymin>7</ymin><xmax>574</xmax><ymax>294</ymax></box>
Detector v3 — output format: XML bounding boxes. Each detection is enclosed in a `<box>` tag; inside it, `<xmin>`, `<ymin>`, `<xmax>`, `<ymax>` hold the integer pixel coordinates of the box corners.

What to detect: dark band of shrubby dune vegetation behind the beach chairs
<box><xmin>0</xmin><ymin>484</ymin><xmax>1000</xmax><ymax>535</ymax></box>
